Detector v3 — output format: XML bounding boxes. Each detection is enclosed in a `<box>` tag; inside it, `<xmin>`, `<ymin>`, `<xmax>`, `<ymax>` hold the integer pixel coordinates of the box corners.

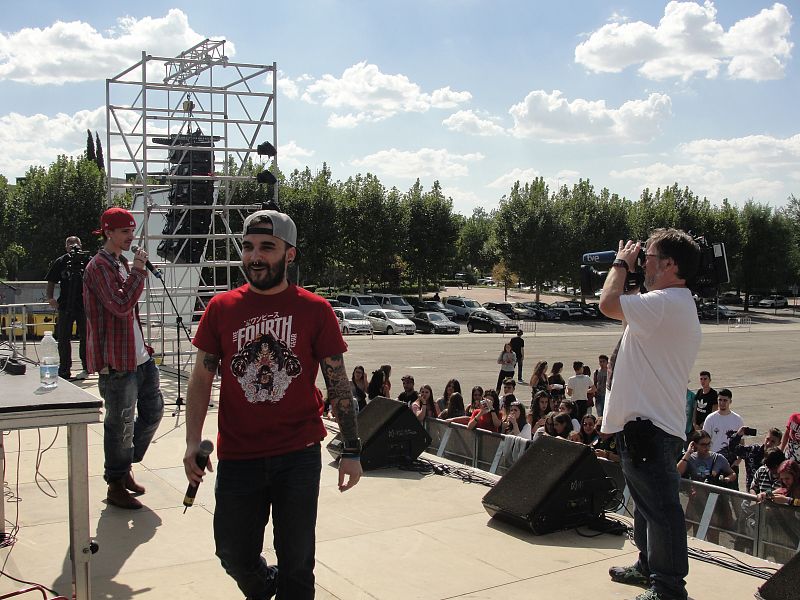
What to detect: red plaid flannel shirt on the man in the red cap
<box><xmin>83</xmin><ymin>248</ymin><xmax>153</xmax><ymax>373</ymax></box>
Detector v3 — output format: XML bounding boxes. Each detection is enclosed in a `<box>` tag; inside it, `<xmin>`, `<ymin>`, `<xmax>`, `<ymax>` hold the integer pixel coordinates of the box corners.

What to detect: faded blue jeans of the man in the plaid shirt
<box><xmin>98</xmin><ymin>358</ymin><xmax>164</xmax><ymax>482</ymax></box>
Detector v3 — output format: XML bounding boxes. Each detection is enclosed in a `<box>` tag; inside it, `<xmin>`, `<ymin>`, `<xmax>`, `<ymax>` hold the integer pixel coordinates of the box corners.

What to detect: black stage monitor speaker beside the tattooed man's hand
<box><xmin>328</xmin><ymin>397</ymin><xmax>431</xmax><ymax>471</ymax></box>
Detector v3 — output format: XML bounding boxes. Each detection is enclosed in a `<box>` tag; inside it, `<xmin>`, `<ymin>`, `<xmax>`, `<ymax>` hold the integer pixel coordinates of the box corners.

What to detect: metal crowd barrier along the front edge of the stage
<box><xmin>424</xmin><ymin>418</ymin><xmax>800</xmax><ymax>564</ymax></box>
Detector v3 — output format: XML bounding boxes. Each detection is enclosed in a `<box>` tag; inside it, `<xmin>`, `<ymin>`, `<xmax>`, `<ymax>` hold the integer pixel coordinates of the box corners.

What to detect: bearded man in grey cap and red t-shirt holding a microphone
<box><xmin>183</xmin><ymin>210</ymin><xmax>361</xmax><ymax>600</ymax></box>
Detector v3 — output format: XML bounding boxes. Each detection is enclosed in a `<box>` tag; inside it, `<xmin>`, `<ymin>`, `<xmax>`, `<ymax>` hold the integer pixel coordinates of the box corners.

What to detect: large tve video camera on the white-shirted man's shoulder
<box><xmin>581</xmin><ymin>236</ymin><xmax>731</xmax><ymax>298</ymax></box>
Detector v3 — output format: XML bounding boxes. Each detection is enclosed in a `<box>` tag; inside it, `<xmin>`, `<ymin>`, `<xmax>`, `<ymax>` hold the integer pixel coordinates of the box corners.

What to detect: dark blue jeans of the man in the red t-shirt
<box><xmin>214</xmin><ymin>444</ymin><xmax>322</xmax><ymax>600</ymax></box>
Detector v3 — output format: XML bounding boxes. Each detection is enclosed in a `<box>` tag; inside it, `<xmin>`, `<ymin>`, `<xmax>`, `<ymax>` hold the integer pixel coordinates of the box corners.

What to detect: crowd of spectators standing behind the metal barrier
<box><xmin>332</xmin><ymin>358</ymin><xmax>800</xmax><ymax>526</ymax></box>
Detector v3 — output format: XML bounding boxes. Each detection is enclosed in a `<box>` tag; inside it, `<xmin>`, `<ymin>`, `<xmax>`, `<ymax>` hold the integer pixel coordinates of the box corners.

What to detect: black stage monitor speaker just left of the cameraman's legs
<box><xmin>483</xmin><ymin>436</ymin><xmax>616</xmax><ymax>535</ymax></box>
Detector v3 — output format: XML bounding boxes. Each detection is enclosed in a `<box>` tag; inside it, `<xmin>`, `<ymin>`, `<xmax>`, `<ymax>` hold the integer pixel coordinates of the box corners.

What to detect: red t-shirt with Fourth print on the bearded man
<box><xmin>192</xmin><ymin>284</ymin><xmax>347</xmax><ymax>460</ymax></box>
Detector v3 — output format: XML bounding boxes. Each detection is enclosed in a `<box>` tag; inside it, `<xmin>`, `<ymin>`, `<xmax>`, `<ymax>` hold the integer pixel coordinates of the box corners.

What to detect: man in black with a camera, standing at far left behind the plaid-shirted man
<box><xmin>45</xmin><ymin>235</ymin><xmax>90</xmax><ymax>379</ymax></box>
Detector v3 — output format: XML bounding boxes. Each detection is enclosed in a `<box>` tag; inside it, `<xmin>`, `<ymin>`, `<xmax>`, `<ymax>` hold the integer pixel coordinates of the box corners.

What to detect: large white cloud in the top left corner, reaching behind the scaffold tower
<box><xmin>0</xmin><ymin>8</ymin><xmax>234</xmax><ymax>85</ymax></box>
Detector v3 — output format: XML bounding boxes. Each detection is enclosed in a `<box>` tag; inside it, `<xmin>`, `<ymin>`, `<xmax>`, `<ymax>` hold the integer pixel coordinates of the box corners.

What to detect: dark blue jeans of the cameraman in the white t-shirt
<box><xmin>617</xmin><ymin>428</ymin><xmax>689</xmax><ymax>600</ymax></box>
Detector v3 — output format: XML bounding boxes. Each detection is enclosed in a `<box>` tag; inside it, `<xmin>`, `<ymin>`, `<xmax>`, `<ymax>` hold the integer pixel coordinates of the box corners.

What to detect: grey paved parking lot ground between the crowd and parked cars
<box><xmin>332</xmin><ymin>288</ymin><xmax>800</xmax><ymax>435</ymax></box>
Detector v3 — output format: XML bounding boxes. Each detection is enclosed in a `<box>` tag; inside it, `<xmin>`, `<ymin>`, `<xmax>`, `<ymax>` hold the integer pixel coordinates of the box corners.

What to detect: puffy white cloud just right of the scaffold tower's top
<box><xmin>301</xmin><ymin>61</ymin><xmax>472</xmax><ymax>127</ymax></box>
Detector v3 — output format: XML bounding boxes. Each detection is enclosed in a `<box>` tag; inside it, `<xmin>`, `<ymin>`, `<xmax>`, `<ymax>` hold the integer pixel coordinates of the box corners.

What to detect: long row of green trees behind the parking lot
<box><xmin>0</xmin><ymin>150</ymin><xmax>800</xmax><ymax>300</ymax></box>
